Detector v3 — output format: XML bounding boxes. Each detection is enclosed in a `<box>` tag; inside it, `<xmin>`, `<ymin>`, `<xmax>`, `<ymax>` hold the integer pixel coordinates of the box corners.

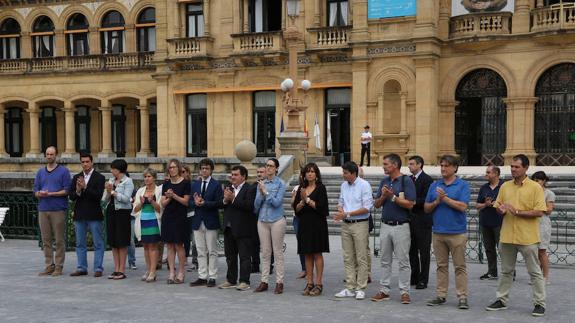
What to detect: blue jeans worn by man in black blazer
<box><xmin>74</xmin><ymin>220</ymin><xmax>105</xmax><ymax>272</ymax></box>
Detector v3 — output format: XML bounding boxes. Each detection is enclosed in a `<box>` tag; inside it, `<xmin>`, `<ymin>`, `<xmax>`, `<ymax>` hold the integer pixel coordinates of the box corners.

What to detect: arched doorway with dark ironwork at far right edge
<box><xmin>535</xmin><ymin>63</ymin><xmax>575</xmax><ymax>166</ymax></box>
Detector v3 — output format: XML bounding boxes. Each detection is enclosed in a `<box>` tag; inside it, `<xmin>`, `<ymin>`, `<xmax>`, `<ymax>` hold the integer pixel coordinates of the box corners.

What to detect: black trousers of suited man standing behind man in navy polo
<box><xmin>409</xmin><ymin>218</ymin><xmax>431</xmax><ymax>285</ymax></box>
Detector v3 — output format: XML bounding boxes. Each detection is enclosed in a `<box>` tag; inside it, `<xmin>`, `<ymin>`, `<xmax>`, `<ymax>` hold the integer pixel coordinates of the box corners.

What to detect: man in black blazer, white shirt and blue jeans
<box><xmin>69</xmin><ymin>153</ymin><xmax>106</xmax><ymax>277</ymax></box>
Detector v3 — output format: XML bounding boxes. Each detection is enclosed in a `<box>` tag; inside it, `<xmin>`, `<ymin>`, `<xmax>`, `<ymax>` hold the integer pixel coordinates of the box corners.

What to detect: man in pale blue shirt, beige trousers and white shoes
<box><xmin>334</xmin><ymin>162</ymin><xmax>373</xmax><ymax>300</ymax></box>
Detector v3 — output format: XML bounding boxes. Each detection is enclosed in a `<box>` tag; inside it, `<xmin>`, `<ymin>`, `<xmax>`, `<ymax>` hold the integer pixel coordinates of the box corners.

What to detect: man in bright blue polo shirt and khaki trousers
<box><xmin>423</xmin><ymin>155</ymin><xmax>471</xmax><ymax>310</ymax></box>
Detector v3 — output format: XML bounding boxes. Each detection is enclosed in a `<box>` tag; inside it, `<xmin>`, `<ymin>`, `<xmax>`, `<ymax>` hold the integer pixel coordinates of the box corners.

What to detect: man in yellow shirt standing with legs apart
<box><xmin>486</xmin><ymin>154</ymin><xmax>547</xmax><ymax>316</ymax></box>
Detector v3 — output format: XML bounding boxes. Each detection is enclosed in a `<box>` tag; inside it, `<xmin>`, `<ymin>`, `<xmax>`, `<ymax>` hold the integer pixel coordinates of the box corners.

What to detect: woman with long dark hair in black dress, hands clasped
<box><xmin>293</xmin><ymin>163</ymin><xmax>329</xmax><ymax>296</ymax></box>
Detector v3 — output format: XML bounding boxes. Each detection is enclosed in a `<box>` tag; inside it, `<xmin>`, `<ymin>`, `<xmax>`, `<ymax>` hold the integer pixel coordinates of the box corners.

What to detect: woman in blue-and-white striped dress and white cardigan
<box><xmin>134</xmin><ymin>168</ymin><xmax>162</xmax><ymax>283</ymax></box>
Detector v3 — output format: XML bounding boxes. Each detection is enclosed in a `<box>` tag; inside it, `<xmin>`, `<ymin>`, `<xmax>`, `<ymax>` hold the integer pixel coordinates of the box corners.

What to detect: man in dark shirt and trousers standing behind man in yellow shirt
<box><xmin>476</xmin><ymin>166</ymin><xmax>503</xmax><ymax>280</ymax></box>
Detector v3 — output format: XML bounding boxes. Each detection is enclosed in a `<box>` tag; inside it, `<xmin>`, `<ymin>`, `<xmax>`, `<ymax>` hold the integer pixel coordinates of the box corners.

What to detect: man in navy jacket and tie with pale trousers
<box><xmin>189</xmin><ymin>158</ymin><xmax>224</xmax><ymax>287</ymax></box>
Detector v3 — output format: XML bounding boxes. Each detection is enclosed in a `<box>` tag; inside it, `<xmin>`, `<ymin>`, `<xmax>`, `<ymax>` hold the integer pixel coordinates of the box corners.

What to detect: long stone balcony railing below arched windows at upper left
<box><xmin>0</xmin><ymin>53</ymin><xmax>154</xmax><ymax>74</ymax></box>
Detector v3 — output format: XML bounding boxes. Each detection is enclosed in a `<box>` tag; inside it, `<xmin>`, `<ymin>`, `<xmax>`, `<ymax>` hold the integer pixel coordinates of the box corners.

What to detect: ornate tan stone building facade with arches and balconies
<box><xmin>0</xmin><ymin>0</ymin><xmax>575</xmax><ymax>170</ymax></box>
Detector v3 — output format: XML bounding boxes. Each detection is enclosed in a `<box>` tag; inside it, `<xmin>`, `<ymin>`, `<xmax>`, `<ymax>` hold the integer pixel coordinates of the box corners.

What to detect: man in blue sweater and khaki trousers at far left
<box><xmin>34</xmin><ymin>146</ymin><xmax>71</xmax><ymax>276</ymax></box>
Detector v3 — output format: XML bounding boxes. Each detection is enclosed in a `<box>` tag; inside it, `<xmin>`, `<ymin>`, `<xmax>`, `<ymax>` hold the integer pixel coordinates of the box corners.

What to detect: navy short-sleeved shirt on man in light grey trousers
<box><xmin>376</xmin><ymin>175</ymin><xmax>416</xmax><ymax>222</ymax></box>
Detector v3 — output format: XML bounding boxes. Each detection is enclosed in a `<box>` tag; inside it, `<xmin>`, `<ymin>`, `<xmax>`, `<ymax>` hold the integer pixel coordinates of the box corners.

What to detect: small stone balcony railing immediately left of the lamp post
<box><xmin>231</xmin><ymin>31</ymin><xmax>284</xmax><ymax>54</ymax></box>
